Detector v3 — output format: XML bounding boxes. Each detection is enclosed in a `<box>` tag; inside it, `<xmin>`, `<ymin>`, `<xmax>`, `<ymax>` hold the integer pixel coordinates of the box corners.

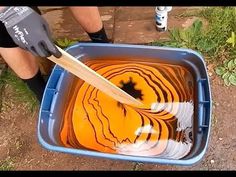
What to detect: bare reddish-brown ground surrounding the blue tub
<box><xmin>0</xmin><ymin>7</ymin><xmax>236</xmax><ymax>171</ymax></box>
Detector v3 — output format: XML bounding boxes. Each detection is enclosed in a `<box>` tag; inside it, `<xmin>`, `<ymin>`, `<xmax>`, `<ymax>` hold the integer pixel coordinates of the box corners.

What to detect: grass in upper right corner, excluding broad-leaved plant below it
<box><xmin>152</xmin><ymin>7</ymin><xmax>236</xmax><ymax>60</ymax></box>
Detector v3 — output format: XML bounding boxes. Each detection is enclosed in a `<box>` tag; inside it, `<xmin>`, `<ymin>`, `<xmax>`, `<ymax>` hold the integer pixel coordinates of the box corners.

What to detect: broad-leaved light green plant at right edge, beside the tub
<box><xmin>215</xmin><ymin>59</ymin><xmax>236</xmax><ymax>86</ymax></box>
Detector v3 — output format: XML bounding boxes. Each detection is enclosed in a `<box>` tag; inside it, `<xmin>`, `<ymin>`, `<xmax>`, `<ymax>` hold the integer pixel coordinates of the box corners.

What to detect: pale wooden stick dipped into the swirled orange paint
<box><xmin>48</xmin><ymin>46</ymin><xmax>142</xmax><ymax>106</ymax></box>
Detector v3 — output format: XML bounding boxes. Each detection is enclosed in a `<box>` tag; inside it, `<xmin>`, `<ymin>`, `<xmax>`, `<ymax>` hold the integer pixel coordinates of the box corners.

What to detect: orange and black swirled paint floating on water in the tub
<box><xmin>60</xmin><ymin>58</ymin><xmax>194</xmax><ymax>159</ymax></box>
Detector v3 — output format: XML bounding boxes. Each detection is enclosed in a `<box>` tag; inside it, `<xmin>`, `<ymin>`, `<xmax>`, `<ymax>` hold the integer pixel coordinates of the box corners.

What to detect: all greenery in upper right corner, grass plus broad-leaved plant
<box><xmin>151</xmin><ymin>7</ymin><xmax>236</xmax><ymax>85</ymax></box>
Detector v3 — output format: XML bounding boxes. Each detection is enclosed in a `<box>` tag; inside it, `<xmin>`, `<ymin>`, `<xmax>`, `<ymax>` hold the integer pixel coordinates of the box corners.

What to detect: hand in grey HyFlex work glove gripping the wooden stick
<box><xmin>0</xmin><ymin>6</ymin><xmax>62</xmax><ymax>58</ymax></box>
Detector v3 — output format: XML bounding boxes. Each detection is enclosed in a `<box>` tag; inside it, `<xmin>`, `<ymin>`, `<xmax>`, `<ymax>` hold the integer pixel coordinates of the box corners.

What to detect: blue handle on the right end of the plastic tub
<box><xmin>197</xmin><ymin>79</ymin><xmax>211</xmax><ymax>131</ymax></box>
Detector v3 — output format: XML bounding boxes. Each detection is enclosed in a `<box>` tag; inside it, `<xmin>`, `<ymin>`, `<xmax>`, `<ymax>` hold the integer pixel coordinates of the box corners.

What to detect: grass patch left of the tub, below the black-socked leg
<box><xmin>0</xmin><ymin>69</ymin><xmax>39</xmax><ymax>112</ymax></box>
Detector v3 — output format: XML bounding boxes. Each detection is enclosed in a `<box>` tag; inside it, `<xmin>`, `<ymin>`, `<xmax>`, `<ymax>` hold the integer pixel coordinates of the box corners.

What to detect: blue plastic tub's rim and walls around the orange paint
<box><xmin>38</xmin><ymin>43</ymin><xmax>212</xmax><ymax>165</ymax></box>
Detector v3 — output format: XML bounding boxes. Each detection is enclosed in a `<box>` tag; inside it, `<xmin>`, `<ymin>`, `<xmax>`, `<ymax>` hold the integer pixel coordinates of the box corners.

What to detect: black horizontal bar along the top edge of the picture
<box><xmin>0</xmin><ymin>0</ymin><xmax>236</xmax><ymax>6</ymax></box>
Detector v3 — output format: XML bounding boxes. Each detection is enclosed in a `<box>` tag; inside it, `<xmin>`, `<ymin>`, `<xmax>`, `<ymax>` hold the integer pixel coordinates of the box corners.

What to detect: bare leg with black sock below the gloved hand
<box><xmin>0</xmin><ymin>47</ymin><xmax>46</xmax><ymax>101</ymax></box>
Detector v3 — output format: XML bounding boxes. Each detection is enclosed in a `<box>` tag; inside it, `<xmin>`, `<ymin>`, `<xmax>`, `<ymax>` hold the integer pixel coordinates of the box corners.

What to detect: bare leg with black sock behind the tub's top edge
<box><xmin>69</xmin><ymin>6</ymin><xmax>110</xmax><ymax>43</ymax></box>
